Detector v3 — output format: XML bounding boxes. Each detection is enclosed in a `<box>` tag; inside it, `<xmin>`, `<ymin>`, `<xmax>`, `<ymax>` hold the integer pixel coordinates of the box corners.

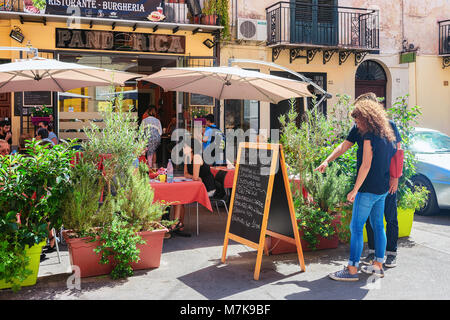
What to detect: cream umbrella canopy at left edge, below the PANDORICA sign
<box><xmin>0</xmin><ymin>58</ymin><xmax>142</xmax><ymax>92</ymax></box>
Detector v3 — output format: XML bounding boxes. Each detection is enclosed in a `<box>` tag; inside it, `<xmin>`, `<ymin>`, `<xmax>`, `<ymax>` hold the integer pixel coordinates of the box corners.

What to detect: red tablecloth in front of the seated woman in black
<box><xmin>150</xmin><ymin>181</ymin><xmax>212</xmax><ymax>211</ymax></box>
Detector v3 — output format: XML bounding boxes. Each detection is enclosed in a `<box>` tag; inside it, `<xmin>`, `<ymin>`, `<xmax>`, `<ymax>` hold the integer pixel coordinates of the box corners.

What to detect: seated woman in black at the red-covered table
<box><xmin>166</xmin><ymin>139</ymin><xmax>216</xmax><ymax>238</ymax></box>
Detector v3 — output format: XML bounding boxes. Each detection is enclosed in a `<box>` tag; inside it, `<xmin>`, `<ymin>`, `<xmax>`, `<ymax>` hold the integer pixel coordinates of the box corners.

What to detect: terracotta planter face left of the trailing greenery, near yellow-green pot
<box><xmin>63</xmin><ymin>230</ymin><xmax>113</xmax><ymax>278</ymax></box>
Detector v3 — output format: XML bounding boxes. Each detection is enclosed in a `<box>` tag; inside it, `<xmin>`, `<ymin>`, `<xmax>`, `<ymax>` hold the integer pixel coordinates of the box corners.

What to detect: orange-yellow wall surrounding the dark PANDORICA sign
<box><xmin>0</xmin><ymin>19</ymin><xmax>213</xmax><ymax>145</ymax></box>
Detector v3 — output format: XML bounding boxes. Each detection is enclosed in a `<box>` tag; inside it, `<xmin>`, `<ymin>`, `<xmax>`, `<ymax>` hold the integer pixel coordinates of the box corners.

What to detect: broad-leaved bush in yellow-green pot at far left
<box><xmin>0</xmin><ymin>140</ymin><xmax>73</xmax><ymax>290</ymax></box>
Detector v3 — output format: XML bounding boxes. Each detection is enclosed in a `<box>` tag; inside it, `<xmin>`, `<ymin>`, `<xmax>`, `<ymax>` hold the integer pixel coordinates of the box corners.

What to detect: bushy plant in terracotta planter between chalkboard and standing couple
<box><xmin>270</xmin><ymin>100</ymin><xmax>350</xmax><ymax>253</ymax></box>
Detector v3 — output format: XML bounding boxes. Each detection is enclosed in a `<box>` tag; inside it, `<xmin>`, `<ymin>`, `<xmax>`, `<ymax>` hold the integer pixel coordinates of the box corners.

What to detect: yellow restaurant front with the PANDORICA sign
<box><xmin>0</xmin><ymin>0</ymin><xmax>222</xmax><ymax>146</ymax></box>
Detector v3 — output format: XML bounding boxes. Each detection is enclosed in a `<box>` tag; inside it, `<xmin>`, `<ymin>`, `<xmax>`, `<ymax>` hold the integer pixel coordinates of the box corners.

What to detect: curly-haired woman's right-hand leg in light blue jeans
<box><xmin>370</xmin><ymin>194</ymin><xmax>386</xmax><ymax>269</ymax></box>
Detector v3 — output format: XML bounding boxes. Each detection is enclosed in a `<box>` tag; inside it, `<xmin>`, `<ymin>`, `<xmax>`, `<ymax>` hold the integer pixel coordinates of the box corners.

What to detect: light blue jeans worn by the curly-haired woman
<box><xmin>348</xmin><ymin>192</ymin><xmax>388</xmax><ymax>267</ymax></box>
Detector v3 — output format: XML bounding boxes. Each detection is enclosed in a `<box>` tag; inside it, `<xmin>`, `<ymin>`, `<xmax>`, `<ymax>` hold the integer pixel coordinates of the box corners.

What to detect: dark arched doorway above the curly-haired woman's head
<box><xmin>355</xmin><ymin>60</ymin><xmax>387</xmax><ymax>107</ymax></box>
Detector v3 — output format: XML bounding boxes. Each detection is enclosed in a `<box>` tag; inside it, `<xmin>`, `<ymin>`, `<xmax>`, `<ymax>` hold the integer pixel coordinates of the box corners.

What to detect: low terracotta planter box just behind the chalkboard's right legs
<box><xmin>266</xmin><ymin>217</ymin><xmax>340</xmax><ymax>254</ymax></box>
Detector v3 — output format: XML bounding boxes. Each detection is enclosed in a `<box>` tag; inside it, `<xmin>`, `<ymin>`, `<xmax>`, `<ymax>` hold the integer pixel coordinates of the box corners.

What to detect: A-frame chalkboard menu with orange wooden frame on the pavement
<box><xmin>222</xmin><ymin>142</ymin><xmax>305</xmax><ymax>280</ymax></box>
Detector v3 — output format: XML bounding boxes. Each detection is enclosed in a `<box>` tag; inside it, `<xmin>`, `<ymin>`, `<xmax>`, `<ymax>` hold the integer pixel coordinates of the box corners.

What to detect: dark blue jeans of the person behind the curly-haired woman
<box><xmin>366</xmin><ymin>192</ymin><xmax>398</xmax><ymax>255</ymax></box>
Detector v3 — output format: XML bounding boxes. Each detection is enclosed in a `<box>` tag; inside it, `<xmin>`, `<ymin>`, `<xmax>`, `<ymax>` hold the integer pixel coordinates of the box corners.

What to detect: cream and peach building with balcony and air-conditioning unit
<box><xmin>220</xmin><ymin>0</ymin><xmax>450</xmax><ymax>134</ymax></box>
